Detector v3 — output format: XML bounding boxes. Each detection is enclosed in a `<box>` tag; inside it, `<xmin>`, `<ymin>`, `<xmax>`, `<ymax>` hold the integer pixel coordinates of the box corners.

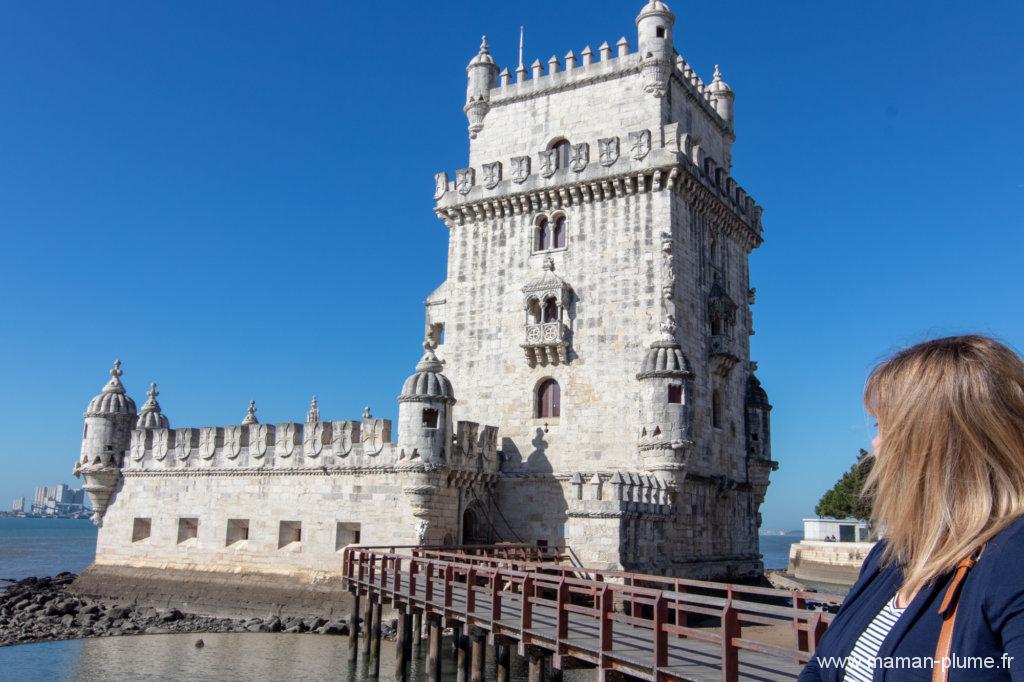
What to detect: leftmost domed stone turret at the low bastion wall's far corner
<box><xmin>74</xmin><ymin>360</ymin><xmax>137</xmax><ymax>525</ymax></box>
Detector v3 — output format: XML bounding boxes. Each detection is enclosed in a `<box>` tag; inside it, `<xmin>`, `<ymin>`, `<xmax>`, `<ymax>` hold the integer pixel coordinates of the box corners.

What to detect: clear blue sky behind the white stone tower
<box><xmin>0</xmin><ymin>0</ymin><xmax>1024</xmax><ymax>528</ymax></box>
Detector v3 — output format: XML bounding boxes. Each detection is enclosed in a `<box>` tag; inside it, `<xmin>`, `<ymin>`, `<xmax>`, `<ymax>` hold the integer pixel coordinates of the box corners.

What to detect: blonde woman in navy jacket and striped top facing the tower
<box><xmin>800</xmin><ymin>336</ymin><xmax>1024</xmax><ymax>682</ymax></box>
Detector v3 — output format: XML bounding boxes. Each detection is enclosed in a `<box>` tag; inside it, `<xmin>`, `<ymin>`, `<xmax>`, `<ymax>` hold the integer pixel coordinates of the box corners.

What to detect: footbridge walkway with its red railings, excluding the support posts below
<box><xmin>345</xmin><ymin>548</ymin><xmax>835</xmax><ymax>682</ymax></box>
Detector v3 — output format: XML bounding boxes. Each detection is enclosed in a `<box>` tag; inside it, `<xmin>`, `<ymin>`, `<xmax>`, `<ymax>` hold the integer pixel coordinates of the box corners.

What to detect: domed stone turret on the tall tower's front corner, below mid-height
<box><xmin>637</xmin><ymin>315</ymin><xmax>693</xmax><ymax>471</ymax></box>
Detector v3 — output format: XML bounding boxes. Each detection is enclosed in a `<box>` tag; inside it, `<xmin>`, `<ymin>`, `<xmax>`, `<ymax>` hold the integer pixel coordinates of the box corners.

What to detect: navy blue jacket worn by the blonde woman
<box><xmin>800</xmin><ymin>516</ymin><xmax>1024</xmax><ymax>682</ymax></box>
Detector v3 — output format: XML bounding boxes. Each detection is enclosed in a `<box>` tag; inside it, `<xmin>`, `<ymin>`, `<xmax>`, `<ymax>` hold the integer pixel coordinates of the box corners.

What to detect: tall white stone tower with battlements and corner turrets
<box><xmin>426</xmin><ymin>0</ymin><xmax>777</xmax><ymax>578</ymax></box>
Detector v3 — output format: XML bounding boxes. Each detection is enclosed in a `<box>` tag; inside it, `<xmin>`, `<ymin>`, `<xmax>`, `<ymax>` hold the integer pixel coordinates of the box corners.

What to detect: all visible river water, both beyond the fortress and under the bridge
<box><xmin>0</xmin><ymin>518</ymin><xmax>811</xmax><ymax>682</ymax></box>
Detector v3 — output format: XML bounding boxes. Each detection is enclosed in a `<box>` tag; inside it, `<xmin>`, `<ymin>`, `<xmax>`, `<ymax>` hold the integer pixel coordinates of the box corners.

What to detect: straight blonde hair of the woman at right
<box><xmin>864</xmin><ymin>336</ymin><xmax>1024</xmax><ymax>594</ymax></box>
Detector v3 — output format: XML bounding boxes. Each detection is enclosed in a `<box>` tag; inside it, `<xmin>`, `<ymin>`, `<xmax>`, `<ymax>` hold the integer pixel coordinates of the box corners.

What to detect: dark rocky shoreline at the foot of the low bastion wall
<box><xmin>0</xmin><ymin>572</ymin><xmax>358</xmax><ymax>646</ymax></box>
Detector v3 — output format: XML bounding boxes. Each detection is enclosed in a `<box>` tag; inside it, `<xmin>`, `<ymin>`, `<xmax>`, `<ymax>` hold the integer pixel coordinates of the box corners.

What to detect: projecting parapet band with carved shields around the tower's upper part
<box><xmin>434</xmin><ymin>123</ymin><xmax>763</xmax><ymax>249</ymax></box>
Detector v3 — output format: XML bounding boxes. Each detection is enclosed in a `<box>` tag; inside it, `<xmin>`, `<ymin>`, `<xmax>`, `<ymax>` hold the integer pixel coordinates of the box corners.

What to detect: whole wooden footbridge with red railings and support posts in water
<box><xmin>344</xmin><ymin>545</ymin><xmax>842</xmax><ymax>682</ymax></box>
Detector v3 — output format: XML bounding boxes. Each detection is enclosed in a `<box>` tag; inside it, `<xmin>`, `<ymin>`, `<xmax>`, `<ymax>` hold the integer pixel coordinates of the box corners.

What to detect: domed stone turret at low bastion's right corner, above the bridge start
<box><xmin>398</xmin><ymin>340</ymin><xmax>456</xmax><ymax>465</ymax></box>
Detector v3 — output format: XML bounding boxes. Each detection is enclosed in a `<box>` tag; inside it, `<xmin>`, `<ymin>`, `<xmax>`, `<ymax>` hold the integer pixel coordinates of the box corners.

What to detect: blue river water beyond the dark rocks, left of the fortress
<box><xmin>0</xmin><ymin>517</ymin><xmax>96</xmax><ymax>586</ymax></box>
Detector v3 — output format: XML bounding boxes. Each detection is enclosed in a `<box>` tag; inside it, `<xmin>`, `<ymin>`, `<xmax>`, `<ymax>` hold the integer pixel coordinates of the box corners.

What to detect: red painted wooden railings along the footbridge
<box><xmin>344</xmin><ymin>546</ymin><xmax>842</xmax><ymax>680</ymax></box>
